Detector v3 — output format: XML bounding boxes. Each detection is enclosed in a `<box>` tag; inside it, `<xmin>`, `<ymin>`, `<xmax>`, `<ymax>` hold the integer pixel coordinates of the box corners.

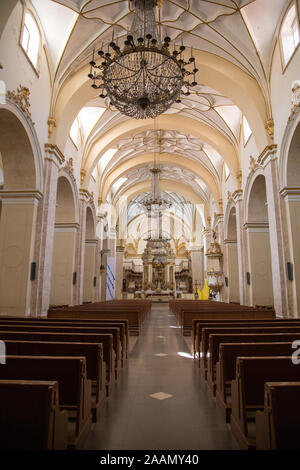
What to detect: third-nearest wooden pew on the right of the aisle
<box><xmin>216</xmin><ymin>341</ymin><xmax>292</xmax><ymax>423</ymax></box>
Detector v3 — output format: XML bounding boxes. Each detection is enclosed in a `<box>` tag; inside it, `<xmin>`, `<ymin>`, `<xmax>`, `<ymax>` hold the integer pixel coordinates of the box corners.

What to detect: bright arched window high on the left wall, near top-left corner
<box><xmin>21</xmin><ymin>11</ymin><xmax>41</xmax><ymax>69</ymax></box>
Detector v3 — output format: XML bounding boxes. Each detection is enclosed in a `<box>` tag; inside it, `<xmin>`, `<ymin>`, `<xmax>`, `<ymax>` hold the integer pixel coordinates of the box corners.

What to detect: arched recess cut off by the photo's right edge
<box><xmin>283</xmin><ymin>122</ymin><xmax>300</xmax><ymax>316</ymax></box>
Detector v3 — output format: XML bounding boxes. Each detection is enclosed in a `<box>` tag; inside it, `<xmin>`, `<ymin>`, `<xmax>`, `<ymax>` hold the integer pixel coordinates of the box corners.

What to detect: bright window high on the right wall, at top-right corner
<box><xmin>280</xmin><ymin>3</ymin><xmax>300</xmax><ymax>67</ymax></box>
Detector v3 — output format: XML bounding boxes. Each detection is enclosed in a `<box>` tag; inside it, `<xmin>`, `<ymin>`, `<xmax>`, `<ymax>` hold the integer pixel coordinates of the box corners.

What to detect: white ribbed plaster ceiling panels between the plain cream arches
<box><xmin>27</xmin><ymin>0</ymin><xmax>289</xmax><ymax>207</ymax></box>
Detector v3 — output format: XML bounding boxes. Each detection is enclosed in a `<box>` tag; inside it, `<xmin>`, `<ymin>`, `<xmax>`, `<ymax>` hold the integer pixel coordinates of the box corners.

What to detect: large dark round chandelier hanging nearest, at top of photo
<box><xmin>88</xmin><ymin>0</ymin><xmax>198</xmax><ymax>119</ymax></box>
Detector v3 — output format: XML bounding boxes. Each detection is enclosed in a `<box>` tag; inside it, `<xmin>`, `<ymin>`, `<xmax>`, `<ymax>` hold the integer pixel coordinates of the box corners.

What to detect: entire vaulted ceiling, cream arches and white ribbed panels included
<box><xmin>31</xmin><ymin>0</ymin><xmax>288</xmax><ymax>228</ymax></box>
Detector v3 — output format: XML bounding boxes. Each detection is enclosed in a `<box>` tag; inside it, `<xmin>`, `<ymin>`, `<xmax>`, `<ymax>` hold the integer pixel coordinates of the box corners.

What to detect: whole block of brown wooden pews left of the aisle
<box><xmin>0</xmin><ymin>301</ymin><xmax>151</xmax><ymax>450</ymax></box>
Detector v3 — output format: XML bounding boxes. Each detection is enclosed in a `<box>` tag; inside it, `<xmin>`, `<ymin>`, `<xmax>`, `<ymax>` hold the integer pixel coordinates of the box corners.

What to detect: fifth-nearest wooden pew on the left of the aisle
<box><xmin>0</xmin><ymin>323</ymin><xmax>121</xmax><ymax>379</ymax></box>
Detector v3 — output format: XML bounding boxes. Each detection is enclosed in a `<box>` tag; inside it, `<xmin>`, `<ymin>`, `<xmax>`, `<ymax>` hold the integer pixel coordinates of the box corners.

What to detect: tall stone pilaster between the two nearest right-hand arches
<box><xmin>258</xmin><ymin>146</ymin><xmax>288</xmax><ymax>316</ymax></box>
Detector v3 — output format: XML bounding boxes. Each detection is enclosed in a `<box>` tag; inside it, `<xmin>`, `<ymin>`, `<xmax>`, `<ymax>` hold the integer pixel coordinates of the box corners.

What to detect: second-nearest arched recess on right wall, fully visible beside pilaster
<box><xmin>245</xmin><ymin>174</ymin><xmax>274</xmax><ymax>306</ymax></box>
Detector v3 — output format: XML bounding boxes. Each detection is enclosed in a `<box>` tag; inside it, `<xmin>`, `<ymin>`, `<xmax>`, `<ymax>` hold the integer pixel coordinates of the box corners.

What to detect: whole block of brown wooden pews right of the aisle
<box><xmin>171</xmin><ymin>301</ymin><xmax>300</xmax><ymax>450</ymax></box>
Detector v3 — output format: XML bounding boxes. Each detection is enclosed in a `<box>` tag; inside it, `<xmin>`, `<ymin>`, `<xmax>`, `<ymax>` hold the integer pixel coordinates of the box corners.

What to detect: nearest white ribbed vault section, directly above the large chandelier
<box><xmin>38</xmin><ymin>0</ymin><xmax>287</xmax><ymax>102</ymax></box>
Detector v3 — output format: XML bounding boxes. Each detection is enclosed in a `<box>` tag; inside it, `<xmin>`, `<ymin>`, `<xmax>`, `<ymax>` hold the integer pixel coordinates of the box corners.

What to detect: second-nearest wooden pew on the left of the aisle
<box><xmin>0</xmin><ymin>356</ymin><xmax>92</xmax><ymax>449</ymax></box>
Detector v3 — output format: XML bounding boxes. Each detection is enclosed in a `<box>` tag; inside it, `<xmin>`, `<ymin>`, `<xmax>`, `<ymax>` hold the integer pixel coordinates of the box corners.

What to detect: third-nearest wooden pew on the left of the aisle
<box><xmin>5</xmin><ymin>340</ymin><xmax>106</xmax><ymax>422</ymax></box>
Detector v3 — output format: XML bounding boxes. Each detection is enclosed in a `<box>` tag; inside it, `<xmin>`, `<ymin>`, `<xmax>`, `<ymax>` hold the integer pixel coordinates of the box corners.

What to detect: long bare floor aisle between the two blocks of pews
<box><xmin>85</xmin><ymin>304</ymin><xmax>237</xmax><ymax>450</ymax></box>
